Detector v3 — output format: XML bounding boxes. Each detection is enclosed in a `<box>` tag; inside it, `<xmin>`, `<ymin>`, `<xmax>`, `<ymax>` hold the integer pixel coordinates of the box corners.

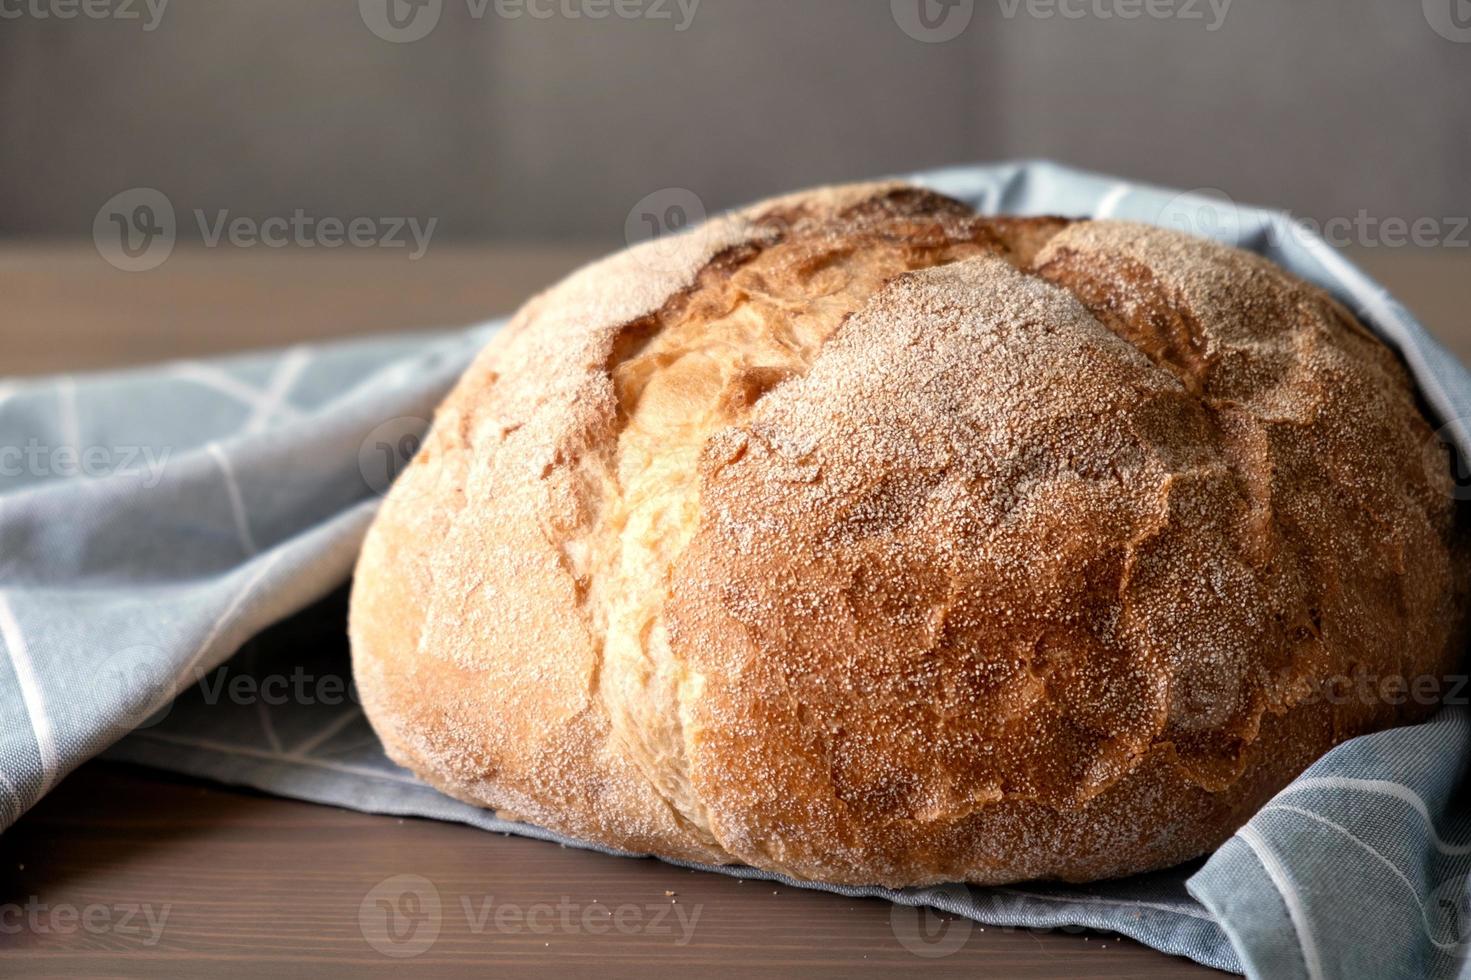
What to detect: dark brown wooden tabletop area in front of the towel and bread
<box><xmin>0</xmin><ymin>762</ymin><xmax>1218</xmax><ymax>977</ymax></box>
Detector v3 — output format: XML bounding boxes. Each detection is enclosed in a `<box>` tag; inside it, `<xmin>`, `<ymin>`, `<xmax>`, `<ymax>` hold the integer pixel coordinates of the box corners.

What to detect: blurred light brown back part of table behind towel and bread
<box><xmin>0</xmin><ymin>240</ymin><xmax>1471</xmax><ymax>375</ymax></box>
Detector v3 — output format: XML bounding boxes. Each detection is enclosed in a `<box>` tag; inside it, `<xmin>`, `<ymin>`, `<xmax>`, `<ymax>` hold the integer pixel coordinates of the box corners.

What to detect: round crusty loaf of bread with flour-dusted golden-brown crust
<box><xmin>352</xmin><ymin>184</ymin><xmax>1468</xmax><ymax>886</ymax></box>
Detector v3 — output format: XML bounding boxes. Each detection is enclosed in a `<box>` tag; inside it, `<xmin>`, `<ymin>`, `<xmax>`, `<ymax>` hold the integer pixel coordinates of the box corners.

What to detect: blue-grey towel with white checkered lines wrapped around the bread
<box><xmin>0</xmin><ymin>163</ymin><xmax>1471</xmax><ymax>979</ymax></box>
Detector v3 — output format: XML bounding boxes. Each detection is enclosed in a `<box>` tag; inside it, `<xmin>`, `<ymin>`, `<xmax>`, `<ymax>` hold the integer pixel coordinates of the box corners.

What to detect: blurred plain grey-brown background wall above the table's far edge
<box><xmin>0</xmin><ymin>0</ymin><xmax>1471</xmax><ymax>240</ymax></box>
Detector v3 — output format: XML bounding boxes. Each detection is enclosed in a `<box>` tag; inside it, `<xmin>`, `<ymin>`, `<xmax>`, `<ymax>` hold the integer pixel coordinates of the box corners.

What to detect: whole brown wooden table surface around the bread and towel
<box><xmin>0</xmin><ymin>243</ymin><xmax>1471</xmax><ymax>977</ymax></box>
